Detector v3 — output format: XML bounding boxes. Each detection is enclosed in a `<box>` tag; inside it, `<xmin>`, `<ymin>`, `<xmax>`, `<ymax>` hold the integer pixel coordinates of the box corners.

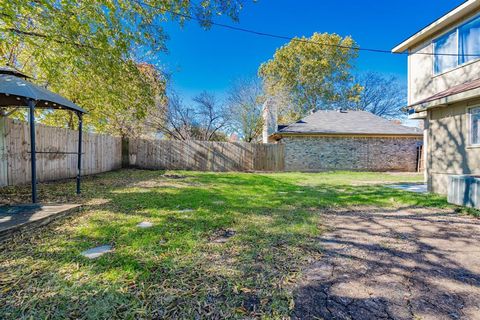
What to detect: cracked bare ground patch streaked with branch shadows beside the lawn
<box><xmin>294</xmin><ymin>208</ymin><xmax>480</xmax><ymax>320</ymax></box>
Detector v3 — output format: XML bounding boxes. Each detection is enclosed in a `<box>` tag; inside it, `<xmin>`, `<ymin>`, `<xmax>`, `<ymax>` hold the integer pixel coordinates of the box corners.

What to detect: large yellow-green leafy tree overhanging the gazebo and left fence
<box><xmin>0</xmin><ymin>0</ymin><xmax>248</xmax><ymax>135</ymax></box>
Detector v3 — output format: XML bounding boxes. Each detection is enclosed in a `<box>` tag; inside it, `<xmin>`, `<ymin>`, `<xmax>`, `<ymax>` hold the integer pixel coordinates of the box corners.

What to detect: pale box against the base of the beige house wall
<box><xmin>448</xmin><ymin>175</ymin><xmax>480</xmax><ymax>209</ymax></box>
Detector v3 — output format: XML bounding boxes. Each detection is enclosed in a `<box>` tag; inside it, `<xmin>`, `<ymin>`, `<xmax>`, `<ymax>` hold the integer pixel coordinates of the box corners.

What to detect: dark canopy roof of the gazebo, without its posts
<box><xmin>0</xmin><ymin>67</ymin><xmax>86</xmax><ymax>113</ymax></box>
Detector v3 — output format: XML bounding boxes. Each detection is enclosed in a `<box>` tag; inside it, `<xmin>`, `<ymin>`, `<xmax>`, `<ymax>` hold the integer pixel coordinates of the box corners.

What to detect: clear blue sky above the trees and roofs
<box><xmin>159</xmin><ymin>0</ymin><xmax>462</xmax><ymax>97</ymax></box>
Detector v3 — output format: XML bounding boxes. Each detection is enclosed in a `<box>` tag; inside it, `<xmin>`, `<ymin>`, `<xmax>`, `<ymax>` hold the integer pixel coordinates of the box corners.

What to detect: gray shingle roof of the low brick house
<box><xmin>277</xmin><ymin>111</ymin><xmax>422</xmax><ymax>135</ymax></box>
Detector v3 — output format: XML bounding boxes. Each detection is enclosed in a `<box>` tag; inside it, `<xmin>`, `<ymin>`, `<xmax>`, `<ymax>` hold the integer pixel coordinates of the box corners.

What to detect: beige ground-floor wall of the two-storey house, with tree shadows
<box><xmin>427</xmin><ymin>100</ymin><xmax>480</xmax><ymax>194</ymax></box>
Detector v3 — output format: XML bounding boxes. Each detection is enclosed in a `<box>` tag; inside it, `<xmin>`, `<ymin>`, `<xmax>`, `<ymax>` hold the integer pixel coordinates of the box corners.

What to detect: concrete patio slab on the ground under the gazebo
<box><xmin>0</xmin><ymin>204</ymin><xmax>80</xmax><ymax>241</ymax></box>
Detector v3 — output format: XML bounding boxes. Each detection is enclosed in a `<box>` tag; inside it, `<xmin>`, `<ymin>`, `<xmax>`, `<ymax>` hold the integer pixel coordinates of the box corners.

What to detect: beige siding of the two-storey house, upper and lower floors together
<box><xmin>408</xmin><ymin>10</ymin><xmax>480</xmax><ymax>194</ymax></box>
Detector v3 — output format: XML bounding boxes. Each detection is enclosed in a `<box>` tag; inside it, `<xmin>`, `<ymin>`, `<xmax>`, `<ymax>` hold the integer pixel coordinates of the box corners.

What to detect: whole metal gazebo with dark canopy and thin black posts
<box><xmin>0</xmin><ymin>67</ymin><xmax>85</xmax><ymax>203</ymax></box>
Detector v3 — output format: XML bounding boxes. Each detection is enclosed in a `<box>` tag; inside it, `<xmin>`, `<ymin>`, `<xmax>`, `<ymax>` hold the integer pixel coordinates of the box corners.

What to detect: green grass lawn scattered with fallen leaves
<box><xmin>0</xmin><ymin>170</ymin><xmax>447</xmax><ymax>319</ymax></box>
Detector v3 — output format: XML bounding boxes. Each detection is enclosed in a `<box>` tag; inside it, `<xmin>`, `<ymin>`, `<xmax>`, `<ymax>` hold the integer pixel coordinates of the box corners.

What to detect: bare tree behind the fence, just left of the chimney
<box><xmin>228</xmin><ymin>79</ymin><xmax>265</xmax><ymax>142</ymax></box>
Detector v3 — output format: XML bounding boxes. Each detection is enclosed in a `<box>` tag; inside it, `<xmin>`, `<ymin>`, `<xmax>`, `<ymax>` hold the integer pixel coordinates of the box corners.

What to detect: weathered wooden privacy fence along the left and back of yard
<box><xmin>0</xmin><ymin>118</ymin><xmax>285</xmax><ymax>186</ymax></box>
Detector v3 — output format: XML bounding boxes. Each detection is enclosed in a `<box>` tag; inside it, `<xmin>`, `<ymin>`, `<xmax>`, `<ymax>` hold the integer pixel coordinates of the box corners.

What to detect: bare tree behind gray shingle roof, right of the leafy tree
<box><xmin>352</xmin><ymin>72</ymin><xmax>407</xmax><ymax>118</ymax></box>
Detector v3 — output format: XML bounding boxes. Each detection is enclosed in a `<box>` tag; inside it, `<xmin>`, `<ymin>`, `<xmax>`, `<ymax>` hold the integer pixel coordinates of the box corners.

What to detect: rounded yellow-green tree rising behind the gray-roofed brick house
<box><xmin>259</xmin><ymin>33</ymin><xmax>361</xmax><ymax>120</ymax></box>
